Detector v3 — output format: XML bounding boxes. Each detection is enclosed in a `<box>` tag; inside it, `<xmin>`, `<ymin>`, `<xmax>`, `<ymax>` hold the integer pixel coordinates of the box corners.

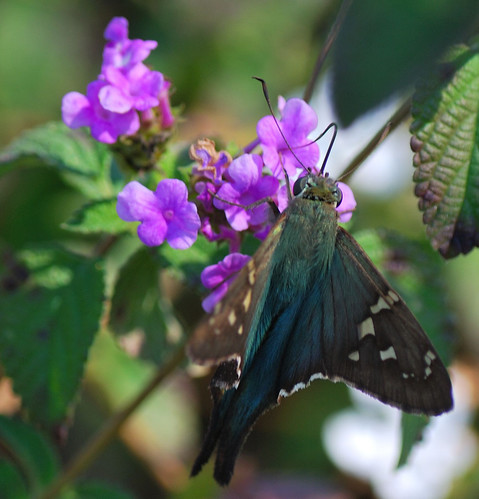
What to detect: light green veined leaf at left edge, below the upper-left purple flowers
<box><xmin>0</xmin><ymin>122</ymin><xmax>119</xmax><ymax>199</ymax></box>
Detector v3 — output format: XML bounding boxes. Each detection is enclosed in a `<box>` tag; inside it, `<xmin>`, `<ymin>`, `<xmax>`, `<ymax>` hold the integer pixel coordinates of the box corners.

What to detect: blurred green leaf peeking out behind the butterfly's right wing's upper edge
<box><xmin>354</xmin><ymin>230</ymin><xmax>453</xmax><ymax>365</ymax></box>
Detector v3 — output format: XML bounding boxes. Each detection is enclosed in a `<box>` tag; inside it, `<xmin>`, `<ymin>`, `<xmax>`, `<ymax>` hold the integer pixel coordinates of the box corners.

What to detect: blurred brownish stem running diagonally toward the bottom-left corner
<box><xmin>38</xmin><ymin>345</ymin><xmax>185</xmax><ymax>499</ymax></box>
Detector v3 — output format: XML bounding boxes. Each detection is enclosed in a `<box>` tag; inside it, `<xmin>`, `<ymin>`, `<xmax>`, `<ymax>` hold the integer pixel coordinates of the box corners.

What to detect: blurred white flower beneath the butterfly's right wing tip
<box><xmin>323</xmin><ymin>370</ymin><xmax>477</xmax><ymax>499</ymax></box>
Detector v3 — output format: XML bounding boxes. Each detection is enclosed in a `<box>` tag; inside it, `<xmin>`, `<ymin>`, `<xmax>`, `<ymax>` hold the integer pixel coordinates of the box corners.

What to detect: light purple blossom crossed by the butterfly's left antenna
<box><xmin>256</xmin><ymin>99</ymin><xmax>319</xmax><ymax>181</ymax></box>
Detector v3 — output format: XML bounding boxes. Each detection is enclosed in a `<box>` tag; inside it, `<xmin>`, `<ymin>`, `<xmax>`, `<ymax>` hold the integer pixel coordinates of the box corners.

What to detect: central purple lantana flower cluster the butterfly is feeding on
<box><xmin>117</xmin><ymin>89</ymin><xmax>356</xmax><ymax>311</ymax></box>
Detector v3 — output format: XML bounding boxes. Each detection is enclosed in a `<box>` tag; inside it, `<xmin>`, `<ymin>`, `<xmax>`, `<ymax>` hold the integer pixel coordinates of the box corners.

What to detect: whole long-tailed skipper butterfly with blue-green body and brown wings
<box><xmin>187</xmin><ymin>91</ymin><xmax>453</xmax><ymax>485</ymax></box>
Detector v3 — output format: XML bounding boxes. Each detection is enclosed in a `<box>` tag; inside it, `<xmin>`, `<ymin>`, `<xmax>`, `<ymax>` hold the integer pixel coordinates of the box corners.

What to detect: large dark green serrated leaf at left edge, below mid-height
<box><xmin>0</xmin><ymin>248</ymin><xmax>104</xmax><ymax>426</ymax></box>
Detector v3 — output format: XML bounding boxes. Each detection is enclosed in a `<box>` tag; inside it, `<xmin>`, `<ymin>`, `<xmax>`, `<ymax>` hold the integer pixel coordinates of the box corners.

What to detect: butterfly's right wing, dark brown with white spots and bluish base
<box><xmin>280</xmin><ymin>227</ymin><xmax>453</xmax><ymax>415</ymax></box>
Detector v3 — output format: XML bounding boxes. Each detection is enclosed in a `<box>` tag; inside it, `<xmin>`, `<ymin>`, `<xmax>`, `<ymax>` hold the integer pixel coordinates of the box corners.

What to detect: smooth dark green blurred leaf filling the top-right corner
<box><xmin>332</xmin><ymin>0</ymin><xmax>477</xmax><ymax>126</ymax></box>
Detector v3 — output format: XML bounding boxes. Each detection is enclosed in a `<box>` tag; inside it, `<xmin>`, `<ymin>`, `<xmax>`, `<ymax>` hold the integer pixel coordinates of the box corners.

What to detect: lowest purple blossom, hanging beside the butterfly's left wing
<box><xmin>201</xmin><ymin>253</ymin><xmax>251</xmax><ymax>312</ymax></box>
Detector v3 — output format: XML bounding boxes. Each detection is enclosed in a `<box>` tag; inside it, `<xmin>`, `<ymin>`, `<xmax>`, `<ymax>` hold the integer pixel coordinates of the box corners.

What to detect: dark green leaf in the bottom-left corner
<box><xmin>0</xmin><ymin>416</ymin><xmax>59</xmax><ymax>499</ymax></box>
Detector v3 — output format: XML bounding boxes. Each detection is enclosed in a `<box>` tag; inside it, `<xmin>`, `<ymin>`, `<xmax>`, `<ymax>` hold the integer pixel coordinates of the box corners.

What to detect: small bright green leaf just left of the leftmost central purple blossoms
<box><xmin>62</xmin><ymin>198</ymin><xmax>131</xmax><ymax>234</ymax></box>
